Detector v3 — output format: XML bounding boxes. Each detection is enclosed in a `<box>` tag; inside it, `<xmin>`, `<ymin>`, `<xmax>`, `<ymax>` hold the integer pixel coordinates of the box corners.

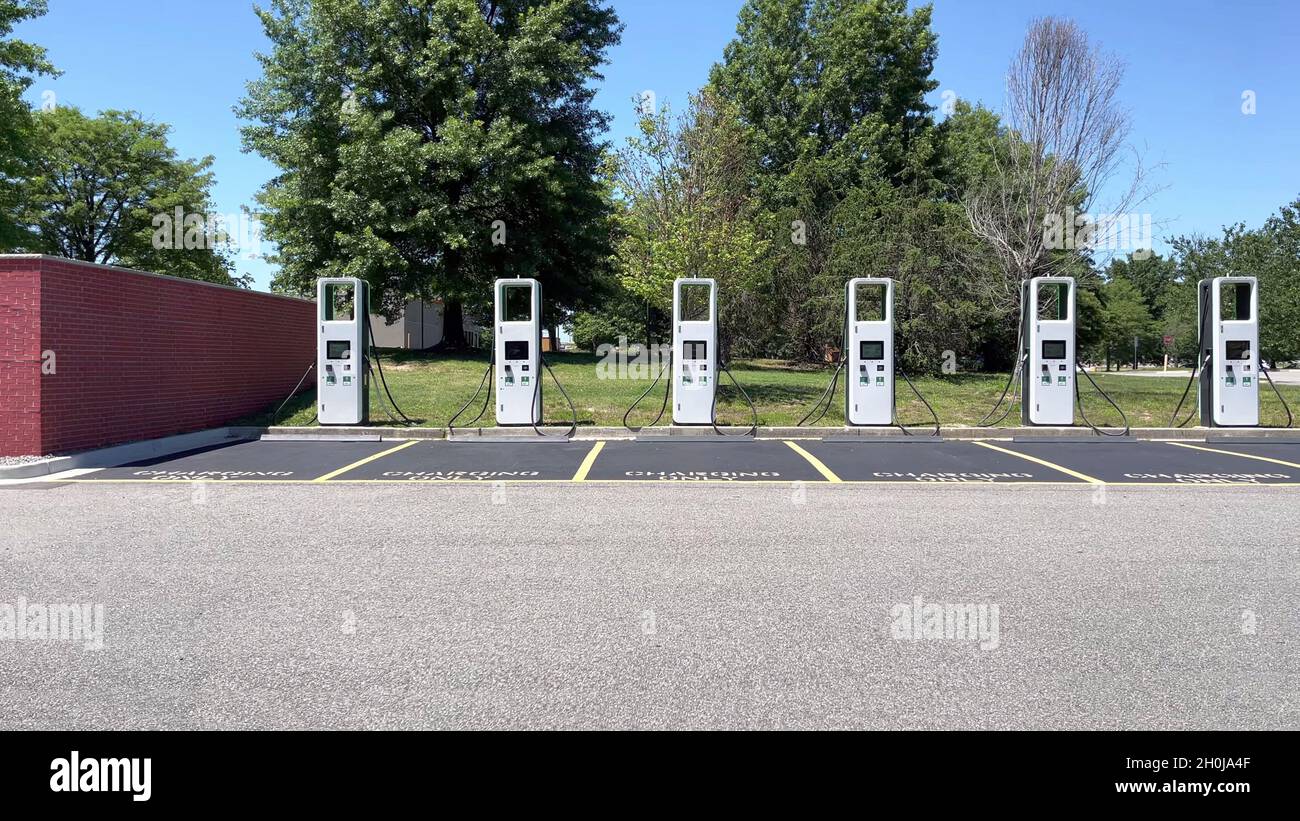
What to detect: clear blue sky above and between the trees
<box><xmin>16</xmin><ymin>0</ymin><xmax>1300</xmax><ymax>288</ymax></box>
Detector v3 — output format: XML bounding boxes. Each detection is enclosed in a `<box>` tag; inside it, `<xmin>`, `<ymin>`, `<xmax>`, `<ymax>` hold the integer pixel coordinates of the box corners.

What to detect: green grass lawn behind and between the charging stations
<box><xmin>250</xmin><ymin>351</ymin><xmax>1300</xmax><ymax>427</ymax></box>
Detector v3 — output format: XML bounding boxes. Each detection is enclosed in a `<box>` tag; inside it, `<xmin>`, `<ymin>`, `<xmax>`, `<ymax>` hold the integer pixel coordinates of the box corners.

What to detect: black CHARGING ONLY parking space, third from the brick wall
<box><xmin>585</xmin><ymin>439</ymin><xmax>828</xmax><ymax>482</ymax></box>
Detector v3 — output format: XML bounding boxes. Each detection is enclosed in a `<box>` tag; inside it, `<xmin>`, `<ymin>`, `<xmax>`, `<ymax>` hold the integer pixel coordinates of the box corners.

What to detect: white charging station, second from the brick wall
<box><xmin>493</xmin><ymin>279</ymin><xmax>542</xmax><ymax>425</ymax></box>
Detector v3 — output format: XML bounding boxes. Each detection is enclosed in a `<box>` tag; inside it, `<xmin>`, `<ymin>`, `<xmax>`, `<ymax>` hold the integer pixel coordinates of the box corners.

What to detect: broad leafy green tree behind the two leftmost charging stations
<box><xmin>238</xmin><ymin>0</ymin><xmax>620</xmax><ymax>347</ymax></box>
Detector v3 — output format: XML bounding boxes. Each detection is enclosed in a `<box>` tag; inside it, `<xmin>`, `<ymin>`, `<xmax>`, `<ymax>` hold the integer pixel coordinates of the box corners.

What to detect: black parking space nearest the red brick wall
<box><xmin>82</xmin><ymin>440</ymin><xmax>398</xmax><ymax>482</ymax></box>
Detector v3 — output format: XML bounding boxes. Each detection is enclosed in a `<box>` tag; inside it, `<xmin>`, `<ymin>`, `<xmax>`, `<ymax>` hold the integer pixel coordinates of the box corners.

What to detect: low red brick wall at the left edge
<box><xmin>0</xmin><ymin>257</ymin><xmax>316</xmax><ymax>455</ymax></box>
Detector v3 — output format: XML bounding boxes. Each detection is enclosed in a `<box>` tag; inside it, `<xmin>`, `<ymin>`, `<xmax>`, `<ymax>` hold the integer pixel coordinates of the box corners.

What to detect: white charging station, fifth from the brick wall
<box><xmin>1021</xmin><ymin>277</ymin><xmax>1075</xmax><ymax>425</ymax></box>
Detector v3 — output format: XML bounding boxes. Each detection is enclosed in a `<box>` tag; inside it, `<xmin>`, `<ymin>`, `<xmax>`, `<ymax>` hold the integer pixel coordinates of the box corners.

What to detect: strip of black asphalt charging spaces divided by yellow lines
<box><xmin>50</xmin><ymin>438</ymin><xmax>1300</xmax><ymax>486</ymax></box>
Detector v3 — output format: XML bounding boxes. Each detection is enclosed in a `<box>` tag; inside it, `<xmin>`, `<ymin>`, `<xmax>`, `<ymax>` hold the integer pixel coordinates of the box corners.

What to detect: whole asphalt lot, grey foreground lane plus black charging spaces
<box><xmin>0</xmin><ymin>440</ymin><xmax>1300</xmax><ymax>729</ymax></box>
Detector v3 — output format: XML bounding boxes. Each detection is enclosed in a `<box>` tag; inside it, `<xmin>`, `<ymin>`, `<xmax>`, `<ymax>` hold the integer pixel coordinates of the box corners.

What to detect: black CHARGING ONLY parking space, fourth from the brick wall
<box><xmin>803</xmin><ymin>440</ymin><xmax>1088</xmax><ymax>485</ymax></box>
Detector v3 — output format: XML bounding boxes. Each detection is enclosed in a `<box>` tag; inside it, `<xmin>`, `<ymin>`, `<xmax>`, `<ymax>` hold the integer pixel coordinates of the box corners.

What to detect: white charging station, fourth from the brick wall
<box><xmin>844</xmin><ymin>277</ymin><xmax>894</xmax><ymax>425</ymax></box>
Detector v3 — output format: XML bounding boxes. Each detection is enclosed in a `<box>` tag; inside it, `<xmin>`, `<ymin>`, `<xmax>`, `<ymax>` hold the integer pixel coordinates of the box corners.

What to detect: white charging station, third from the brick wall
<box><xmin>672</xmin><ymin>278</ymin><xmax>718</xmax><ymax>425</ymax></box>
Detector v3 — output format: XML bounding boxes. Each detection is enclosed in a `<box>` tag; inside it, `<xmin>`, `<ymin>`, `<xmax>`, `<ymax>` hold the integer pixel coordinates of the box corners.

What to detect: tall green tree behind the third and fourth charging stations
<box><xmin>711</xmin><ymin>0</ymin><xmax>937</xmax><ymax>357</ymax></box>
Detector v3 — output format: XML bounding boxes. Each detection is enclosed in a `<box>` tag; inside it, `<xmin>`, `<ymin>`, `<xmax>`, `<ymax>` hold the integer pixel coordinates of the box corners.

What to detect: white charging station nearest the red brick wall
<box><xmin>316</xmin><ymin>277</ymin><xmax>371</xmax><ymax>425</ymax></box>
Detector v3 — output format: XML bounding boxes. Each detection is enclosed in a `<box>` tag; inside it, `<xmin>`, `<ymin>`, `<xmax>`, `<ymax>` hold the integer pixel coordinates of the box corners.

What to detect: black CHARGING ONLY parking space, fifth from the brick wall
<box><xmin>998</xmin><ymin>440</ymin><xmax>1300</xmax><ymax>485</ymax></box>
